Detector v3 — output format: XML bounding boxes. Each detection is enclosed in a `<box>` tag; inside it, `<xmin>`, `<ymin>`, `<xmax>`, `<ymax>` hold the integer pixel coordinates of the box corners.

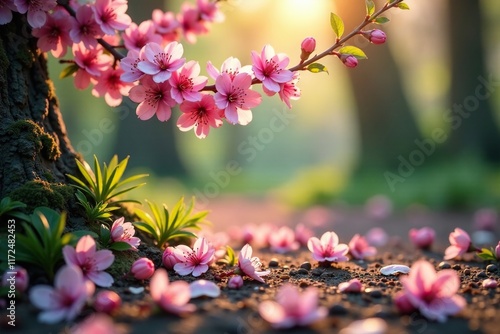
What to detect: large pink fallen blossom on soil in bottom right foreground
<box><xmin>401</xmin><ymin>260</ymin><xmax>466</xmax><ymax>322</ymax></box>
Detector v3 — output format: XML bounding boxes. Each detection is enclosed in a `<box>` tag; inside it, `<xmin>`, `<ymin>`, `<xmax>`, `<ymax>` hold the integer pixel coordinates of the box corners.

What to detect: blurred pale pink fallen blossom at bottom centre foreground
<box><xmin>259</xmin><ymin>283</ymin><xmax>328</xmax><ymax>328</ymax></box>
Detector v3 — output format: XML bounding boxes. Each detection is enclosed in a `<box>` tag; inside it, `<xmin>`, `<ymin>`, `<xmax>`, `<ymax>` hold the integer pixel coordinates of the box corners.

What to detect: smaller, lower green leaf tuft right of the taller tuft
<box><xmin>134</xmin><ymin>197</ymin><xmax>208</xmax><ymax>248</ymax></box>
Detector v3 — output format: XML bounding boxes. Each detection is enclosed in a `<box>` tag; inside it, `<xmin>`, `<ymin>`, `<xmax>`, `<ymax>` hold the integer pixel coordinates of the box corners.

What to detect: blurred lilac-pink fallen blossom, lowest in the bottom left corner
<box><xmin>29</xmin><ymin>266</ymin><xmax>95</xmax><ymax>324</ymax></box>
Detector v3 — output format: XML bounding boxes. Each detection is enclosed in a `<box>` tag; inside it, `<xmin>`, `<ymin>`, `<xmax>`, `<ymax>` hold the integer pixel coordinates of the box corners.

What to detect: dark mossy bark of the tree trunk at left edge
<box><xmin>0</xmin><ymin>15</ymin><xmax>76</xmax><ymax>205</ymax></box>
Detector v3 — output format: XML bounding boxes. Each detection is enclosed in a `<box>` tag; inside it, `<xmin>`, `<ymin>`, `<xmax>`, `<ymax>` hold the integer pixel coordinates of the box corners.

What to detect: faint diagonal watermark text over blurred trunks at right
<box><xmin>384</xmin><ymin>74</ymin><xmax>500</xmax><ymax>192</ymax></box>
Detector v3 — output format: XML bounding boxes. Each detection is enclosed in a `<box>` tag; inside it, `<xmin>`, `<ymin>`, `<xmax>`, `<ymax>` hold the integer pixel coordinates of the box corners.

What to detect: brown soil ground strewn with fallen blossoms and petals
<box><xmin>0</xmin><ymin>198</ymin><xmax>500</xmax><ymax>334</ymax></box>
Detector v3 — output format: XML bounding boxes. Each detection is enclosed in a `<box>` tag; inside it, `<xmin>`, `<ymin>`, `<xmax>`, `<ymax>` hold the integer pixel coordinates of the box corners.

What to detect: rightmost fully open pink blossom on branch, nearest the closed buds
<box><xmin>252</xmin><ymin>45</ymin><xmax>293</xmax><ymax>93</ymax></box>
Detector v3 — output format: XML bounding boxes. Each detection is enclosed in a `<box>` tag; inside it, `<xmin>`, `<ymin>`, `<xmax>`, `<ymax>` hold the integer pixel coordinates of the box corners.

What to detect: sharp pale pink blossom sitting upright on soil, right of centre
<box><xmin>307</xmin><ymin>231</ymin><xmax>349</xmax><ymax>262</ymax></box>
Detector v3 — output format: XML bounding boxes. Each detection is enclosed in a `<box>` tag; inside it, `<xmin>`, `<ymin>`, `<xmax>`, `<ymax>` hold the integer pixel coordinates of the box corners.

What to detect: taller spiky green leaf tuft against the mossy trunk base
<box><xmin>68</xmin><ymin>155</ymin><xmax>148</xmax><ymax>221</ymax></box>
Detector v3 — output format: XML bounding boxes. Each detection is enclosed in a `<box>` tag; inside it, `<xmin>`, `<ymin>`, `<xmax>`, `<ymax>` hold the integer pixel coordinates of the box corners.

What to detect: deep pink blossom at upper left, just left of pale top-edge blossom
<box><xmin>69</xmin><ymin>5</ymin><xmax>104</xmax><ymax>47</ymax></box>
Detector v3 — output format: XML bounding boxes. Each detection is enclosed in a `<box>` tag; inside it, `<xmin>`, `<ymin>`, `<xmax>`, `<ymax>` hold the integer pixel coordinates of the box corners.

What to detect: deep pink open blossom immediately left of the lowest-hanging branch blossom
<box><xmin>129</xmin><ymin>76</ymin><xmax>177</xmax><ymax>122</ymax></box>
